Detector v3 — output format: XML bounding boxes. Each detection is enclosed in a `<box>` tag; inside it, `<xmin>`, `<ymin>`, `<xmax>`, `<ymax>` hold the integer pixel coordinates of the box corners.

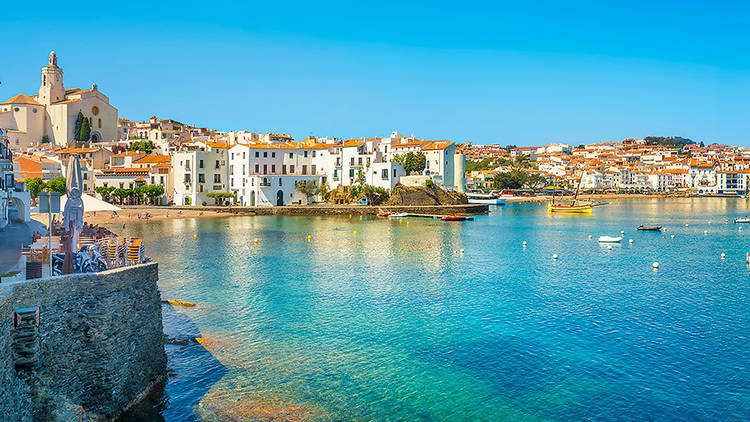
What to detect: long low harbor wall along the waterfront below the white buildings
<box><xmin>125</xmin><ymin>204</ymin><xmax>489</xmax><ymax>215</ymax></box>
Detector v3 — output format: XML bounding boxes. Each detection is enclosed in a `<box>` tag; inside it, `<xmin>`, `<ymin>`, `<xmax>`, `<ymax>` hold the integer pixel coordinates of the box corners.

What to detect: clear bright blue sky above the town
<box><xmin>0</xmin><ymin>0</ymin><xmax>750</xmax><ymax>146</ymax></box>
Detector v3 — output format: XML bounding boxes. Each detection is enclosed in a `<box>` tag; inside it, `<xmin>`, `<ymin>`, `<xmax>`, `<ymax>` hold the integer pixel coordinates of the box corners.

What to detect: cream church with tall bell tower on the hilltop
<box><xmin>0</xmin><ymin>51</ymin><xmax>118</xmax><ymax>150</ymax></box>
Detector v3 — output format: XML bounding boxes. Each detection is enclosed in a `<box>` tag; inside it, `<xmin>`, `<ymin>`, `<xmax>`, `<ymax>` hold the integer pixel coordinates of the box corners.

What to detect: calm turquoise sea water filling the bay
<box><xmin>120</xmin><ymin>199</ymin><xmax>750</xmax><ymax>421</ymax></box>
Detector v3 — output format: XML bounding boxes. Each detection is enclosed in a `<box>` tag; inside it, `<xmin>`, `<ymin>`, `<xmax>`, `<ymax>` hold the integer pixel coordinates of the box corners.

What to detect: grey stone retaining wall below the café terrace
<box><xmin>0</xmin><ymin>263</ymin><xmax>167</xmax><ymax>421</ymax></box>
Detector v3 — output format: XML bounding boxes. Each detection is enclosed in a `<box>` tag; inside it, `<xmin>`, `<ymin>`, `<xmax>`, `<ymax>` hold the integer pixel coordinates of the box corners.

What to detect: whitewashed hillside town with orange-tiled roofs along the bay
<box><xmin>0</xmin><ymin>52</ymin><xmax>750</xmax><ymax>231</ymax></box>
